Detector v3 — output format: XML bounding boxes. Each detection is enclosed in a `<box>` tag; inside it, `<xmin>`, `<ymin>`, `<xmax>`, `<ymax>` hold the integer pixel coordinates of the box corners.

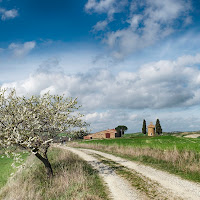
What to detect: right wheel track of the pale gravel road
<box><xmin>81</xmin><ymin>149</ymin><xmax>200</xmax><ymax>200</ymax></box>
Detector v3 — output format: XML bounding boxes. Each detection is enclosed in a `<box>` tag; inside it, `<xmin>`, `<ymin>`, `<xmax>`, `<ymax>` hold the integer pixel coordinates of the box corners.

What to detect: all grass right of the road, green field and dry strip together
<box><xmin>68</xmin><ymin>136</ymin><xmax>200</xmax><ymax>182</ymax></box>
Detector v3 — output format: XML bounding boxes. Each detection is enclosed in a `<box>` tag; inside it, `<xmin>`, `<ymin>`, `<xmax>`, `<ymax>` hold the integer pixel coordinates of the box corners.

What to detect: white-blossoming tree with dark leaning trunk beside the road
<box><xmin>0</xmin><ymin>88</ymin><xmax>87</xmax><ymax>177</ymax></box>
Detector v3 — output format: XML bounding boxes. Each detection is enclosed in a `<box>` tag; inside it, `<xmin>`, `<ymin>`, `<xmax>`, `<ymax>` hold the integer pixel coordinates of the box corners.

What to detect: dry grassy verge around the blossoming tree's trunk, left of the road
<box><xmin>0</xmin><ymin>148</ymin><xmax>109</xmax><ymax>200</ymax></box>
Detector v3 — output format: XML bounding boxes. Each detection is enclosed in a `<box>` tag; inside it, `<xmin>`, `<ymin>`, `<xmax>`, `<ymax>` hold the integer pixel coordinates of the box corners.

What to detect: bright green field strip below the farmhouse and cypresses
<box><xmin>82</xmin><ymin>134</ymin><xmax>200</xmax><ymax>152</ymax></box>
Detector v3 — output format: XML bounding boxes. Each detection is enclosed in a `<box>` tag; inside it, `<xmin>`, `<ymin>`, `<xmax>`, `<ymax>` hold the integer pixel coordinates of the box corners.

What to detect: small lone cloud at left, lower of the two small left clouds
<box><xmin>8</xmin><ymin>41</ymin><xmax>36</xmax><ymax>57</ymax></box>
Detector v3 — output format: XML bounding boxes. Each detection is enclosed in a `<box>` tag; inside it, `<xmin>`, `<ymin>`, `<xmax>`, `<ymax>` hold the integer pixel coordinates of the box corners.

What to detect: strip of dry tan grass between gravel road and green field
<box><xmin>68</xmin><ymin>142</ymin><xmax>200</xmax><ymax>182</ymax></box>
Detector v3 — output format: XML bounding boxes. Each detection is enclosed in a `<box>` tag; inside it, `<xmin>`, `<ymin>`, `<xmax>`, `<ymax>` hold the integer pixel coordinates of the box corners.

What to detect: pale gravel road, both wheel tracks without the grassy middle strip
<box><xmin>55</xmin><ymin>146</ymin><xmax>200</xmax><ymax>200</ymax></box>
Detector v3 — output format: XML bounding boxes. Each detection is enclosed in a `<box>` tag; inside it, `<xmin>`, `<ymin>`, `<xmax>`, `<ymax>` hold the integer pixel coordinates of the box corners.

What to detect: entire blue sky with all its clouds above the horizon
<box><xmin>0</xmin><ymin>0</ymin><xmax>200</xmax><ymax>133</ymax></box>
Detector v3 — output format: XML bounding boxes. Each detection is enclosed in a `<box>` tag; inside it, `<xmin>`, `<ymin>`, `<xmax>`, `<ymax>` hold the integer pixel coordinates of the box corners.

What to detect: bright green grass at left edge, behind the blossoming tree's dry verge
<box><xmin>0</xmin><ymin>153</ymin><xmax>29</xmax><ymax>189</ymax></box>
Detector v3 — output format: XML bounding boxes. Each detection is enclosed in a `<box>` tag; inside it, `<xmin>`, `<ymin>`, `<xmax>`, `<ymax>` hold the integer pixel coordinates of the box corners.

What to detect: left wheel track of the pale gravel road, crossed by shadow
<box><xmin>57</xmin><ymin>146</ymin><xmax>143</xmax><ymax>200</ymax></box>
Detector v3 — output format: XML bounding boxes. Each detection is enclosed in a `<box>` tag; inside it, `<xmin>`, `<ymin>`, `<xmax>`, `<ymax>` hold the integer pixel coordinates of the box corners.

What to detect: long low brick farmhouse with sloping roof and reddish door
<box><xmin>84</xmin><ymin>129</ymin><xmax>117</xmax><ymax>139</ymax></box>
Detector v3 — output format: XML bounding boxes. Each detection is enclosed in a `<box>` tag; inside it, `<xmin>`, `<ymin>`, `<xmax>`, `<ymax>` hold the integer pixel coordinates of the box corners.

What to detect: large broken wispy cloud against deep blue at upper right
<box><xmin>85</xmin><ymin>0</ymin><xmax>192</xmax><ymax>59</ymax></box>
